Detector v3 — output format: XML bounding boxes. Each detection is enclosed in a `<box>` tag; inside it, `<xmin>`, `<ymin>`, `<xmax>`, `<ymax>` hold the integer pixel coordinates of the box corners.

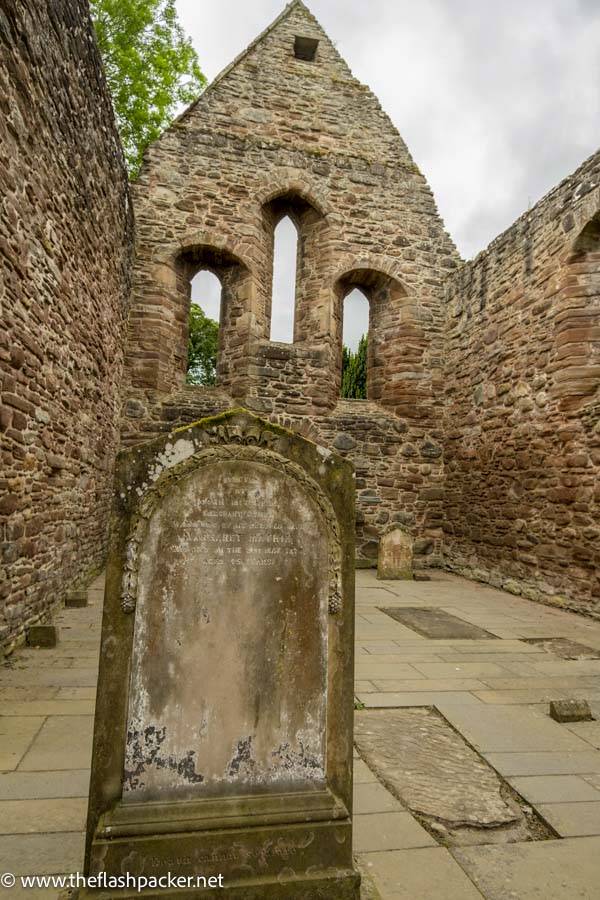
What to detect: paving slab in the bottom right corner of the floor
<box><xmin>452</xmin><ymin>837</ymin><xmax>600</xmax><ymax>900</ymax></box>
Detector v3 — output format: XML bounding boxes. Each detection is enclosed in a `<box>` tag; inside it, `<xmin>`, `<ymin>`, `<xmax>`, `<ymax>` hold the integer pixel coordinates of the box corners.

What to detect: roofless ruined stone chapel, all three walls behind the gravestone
<box><xmin>0</xmin><ymin>0</ymin><xmax>600</xmax><ymax>649</ymax></box>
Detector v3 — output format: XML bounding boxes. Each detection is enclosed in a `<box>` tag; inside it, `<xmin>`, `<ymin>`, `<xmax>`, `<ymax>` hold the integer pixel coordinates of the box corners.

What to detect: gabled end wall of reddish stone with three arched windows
<box><xmin>123</xmin><ymin>0</ymin><xmax>459</xmax><ymax>564</ymax></box>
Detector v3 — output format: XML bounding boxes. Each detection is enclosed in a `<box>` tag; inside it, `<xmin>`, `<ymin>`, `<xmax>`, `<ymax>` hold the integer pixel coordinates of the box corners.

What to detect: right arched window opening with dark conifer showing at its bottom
<box><xmin>341</xmin><ymin>288</ymin><xmax>369</xmax><ymax>400</ymax></box>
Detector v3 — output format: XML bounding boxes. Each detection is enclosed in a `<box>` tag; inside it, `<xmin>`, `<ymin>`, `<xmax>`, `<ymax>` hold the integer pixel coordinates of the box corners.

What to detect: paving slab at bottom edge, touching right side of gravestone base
<box><xmin>358</xmin><ymin>847</ymin><xmax>486</xmax><ymax>900</ymax></box>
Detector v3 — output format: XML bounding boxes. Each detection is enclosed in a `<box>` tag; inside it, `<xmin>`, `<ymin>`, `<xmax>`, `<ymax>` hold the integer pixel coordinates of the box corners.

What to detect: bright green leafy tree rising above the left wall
<box><xmin>90</xmin><ymin>0</ymin><xmax>206</xmax><ymax>177</ymax></box>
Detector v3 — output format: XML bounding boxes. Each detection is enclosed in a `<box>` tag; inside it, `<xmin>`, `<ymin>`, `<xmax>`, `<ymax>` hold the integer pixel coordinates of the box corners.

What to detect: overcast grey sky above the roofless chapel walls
<box><xmin>184</xmin><ymin>0</ymin><xmax>600</xmax><ymax>342</ymax></box>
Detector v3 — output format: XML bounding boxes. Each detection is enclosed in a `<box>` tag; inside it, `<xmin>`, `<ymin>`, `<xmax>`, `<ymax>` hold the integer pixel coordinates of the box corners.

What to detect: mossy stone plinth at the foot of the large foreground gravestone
<box><xmin>78</xmin><ymin>819</ymin><xmax>360</xmax><ymax>900</ymax></box>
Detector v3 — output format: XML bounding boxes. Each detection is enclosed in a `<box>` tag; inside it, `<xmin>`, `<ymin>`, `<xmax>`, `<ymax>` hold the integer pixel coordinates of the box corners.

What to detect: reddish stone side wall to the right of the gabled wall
<box><xmin>445</xmin><ymin>153</ymin><xmax>600</xmax><ymax>612</ymax></box>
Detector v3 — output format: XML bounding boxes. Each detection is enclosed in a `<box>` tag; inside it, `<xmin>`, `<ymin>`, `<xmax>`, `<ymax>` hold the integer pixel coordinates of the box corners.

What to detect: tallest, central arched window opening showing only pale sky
<box><xmin>270</xmin><ymin>216</ymin><xmax>298</xmax><ymax>344</ymax></box>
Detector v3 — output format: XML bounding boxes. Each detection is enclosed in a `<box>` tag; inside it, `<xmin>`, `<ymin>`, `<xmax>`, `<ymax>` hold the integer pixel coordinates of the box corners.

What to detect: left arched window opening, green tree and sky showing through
<box><xmin>185</xmin><ymin>269</ymin><xmax>221</xmax><ymax>385</ymax></box>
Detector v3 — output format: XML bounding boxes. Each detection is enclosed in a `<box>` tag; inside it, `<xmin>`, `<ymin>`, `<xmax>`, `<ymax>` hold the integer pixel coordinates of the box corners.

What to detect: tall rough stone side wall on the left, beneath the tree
<box><xmin>0</xmin><ymin>0</ymin><xmax>132</xmax><ymax>647</ymax></box>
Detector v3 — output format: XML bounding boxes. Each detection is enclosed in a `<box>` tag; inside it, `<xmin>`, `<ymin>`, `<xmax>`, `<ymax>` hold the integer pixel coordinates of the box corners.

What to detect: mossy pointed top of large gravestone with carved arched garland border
<box><xmin>114</xmin><ymin>409</ymin><xmax>354</xmax><ymax>614</ymax></box>
